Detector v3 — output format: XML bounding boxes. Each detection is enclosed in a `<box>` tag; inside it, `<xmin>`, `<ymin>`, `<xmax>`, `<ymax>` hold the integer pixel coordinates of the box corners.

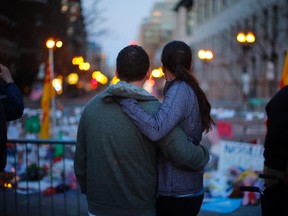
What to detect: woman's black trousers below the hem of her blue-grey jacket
<box><xmin>157</xmin><ymin>194</ymin><xmax>204</xmax><ymax>216</ymax></box>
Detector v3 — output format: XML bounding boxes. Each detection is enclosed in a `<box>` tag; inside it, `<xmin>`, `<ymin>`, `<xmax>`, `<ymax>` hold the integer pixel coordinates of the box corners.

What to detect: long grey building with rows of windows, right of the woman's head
<box><xmin>187</xmin><ymin>0</ymin><xmax>288</xmax><ymax>104</ymax></box>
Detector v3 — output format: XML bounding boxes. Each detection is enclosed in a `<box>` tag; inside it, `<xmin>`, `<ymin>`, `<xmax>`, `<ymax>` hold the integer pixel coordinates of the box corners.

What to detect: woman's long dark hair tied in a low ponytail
<box><xmin>161</xmin><ymin>41</ymin><xmax>215</xmax><ymax>132</ymax></box>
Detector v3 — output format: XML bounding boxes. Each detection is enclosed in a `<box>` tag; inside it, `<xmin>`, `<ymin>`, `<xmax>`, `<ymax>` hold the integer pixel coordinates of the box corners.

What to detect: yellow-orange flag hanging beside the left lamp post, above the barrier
<box><xmin>40</xmin><ymin>64</ymin><xmax>55</xmax><ymax>139</ymax></box>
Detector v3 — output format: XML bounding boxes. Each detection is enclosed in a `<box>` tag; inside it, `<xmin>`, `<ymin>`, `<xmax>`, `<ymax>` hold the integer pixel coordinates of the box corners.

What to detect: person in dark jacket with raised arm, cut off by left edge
<box><xmin>0</xmin><ymin>64</ymin><xmax>24</xmax><ymax>172</ymax></box>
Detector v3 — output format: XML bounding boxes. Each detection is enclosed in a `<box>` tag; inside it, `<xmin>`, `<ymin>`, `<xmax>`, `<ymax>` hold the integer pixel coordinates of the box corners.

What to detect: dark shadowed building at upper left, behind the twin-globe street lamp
<box><xmin>0</xmin><ymin>0</ymin><xmax>86</xmax><ymax>95</ymax></box>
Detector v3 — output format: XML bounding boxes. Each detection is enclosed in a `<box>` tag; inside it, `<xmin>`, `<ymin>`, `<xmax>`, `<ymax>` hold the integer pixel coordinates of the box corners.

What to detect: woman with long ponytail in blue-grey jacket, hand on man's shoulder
<box><xmin>119</xmin><ymin>41</ymin><xmax>215</xmax><ymax>216</ymax></box>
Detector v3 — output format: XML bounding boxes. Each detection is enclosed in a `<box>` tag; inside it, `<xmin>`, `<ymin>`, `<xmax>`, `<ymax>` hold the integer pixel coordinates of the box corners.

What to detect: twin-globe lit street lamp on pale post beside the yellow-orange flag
<box><xmin>46</xmin><ymin>38</ymin><xmax>63</xmax><ymax>136</ymax></box>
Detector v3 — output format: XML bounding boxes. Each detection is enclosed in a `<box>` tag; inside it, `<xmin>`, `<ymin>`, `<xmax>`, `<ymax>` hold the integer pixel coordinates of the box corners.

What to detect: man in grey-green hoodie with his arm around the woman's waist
<box><xmin>74</xmin><ymin>45</ymin><xmax>209</xmax><ymax>216</ymax></box>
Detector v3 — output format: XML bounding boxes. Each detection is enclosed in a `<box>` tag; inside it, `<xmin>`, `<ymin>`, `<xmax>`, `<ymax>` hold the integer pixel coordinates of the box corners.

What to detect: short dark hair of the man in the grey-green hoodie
<box><xmin>116</xmin><ymin>45</ymin><xmax>150</xmax><ymax>82</ymax></box>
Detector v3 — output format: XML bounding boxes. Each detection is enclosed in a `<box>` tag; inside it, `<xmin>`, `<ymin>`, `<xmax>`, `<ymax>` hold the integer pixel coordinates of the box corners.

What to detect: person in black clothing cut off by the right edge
<box><xmin>261</xmin><ymin>85</ymin><xmax>288</xmax><ymax>216</ymax></box>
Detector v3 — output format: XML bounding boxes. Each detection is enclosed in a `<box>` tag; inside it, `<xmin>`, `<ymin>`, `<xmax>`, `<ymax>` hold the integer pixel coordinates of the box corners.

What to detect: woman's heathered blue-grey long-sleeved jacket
<box><xmin>120</xmin><ymin>80</ymin><xmax>204</xmax><ymax>196</ymax></box>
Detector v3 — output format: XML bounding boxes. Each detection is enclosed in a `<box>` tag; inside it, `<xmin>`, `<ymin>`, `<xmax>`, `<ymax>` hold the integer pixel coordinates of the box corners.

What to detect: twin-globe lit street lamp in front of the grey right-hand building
<box><xmin>236</xmin><ymin>32</ymin><xmax>256</xmax><ymax>105</ymax></box>
